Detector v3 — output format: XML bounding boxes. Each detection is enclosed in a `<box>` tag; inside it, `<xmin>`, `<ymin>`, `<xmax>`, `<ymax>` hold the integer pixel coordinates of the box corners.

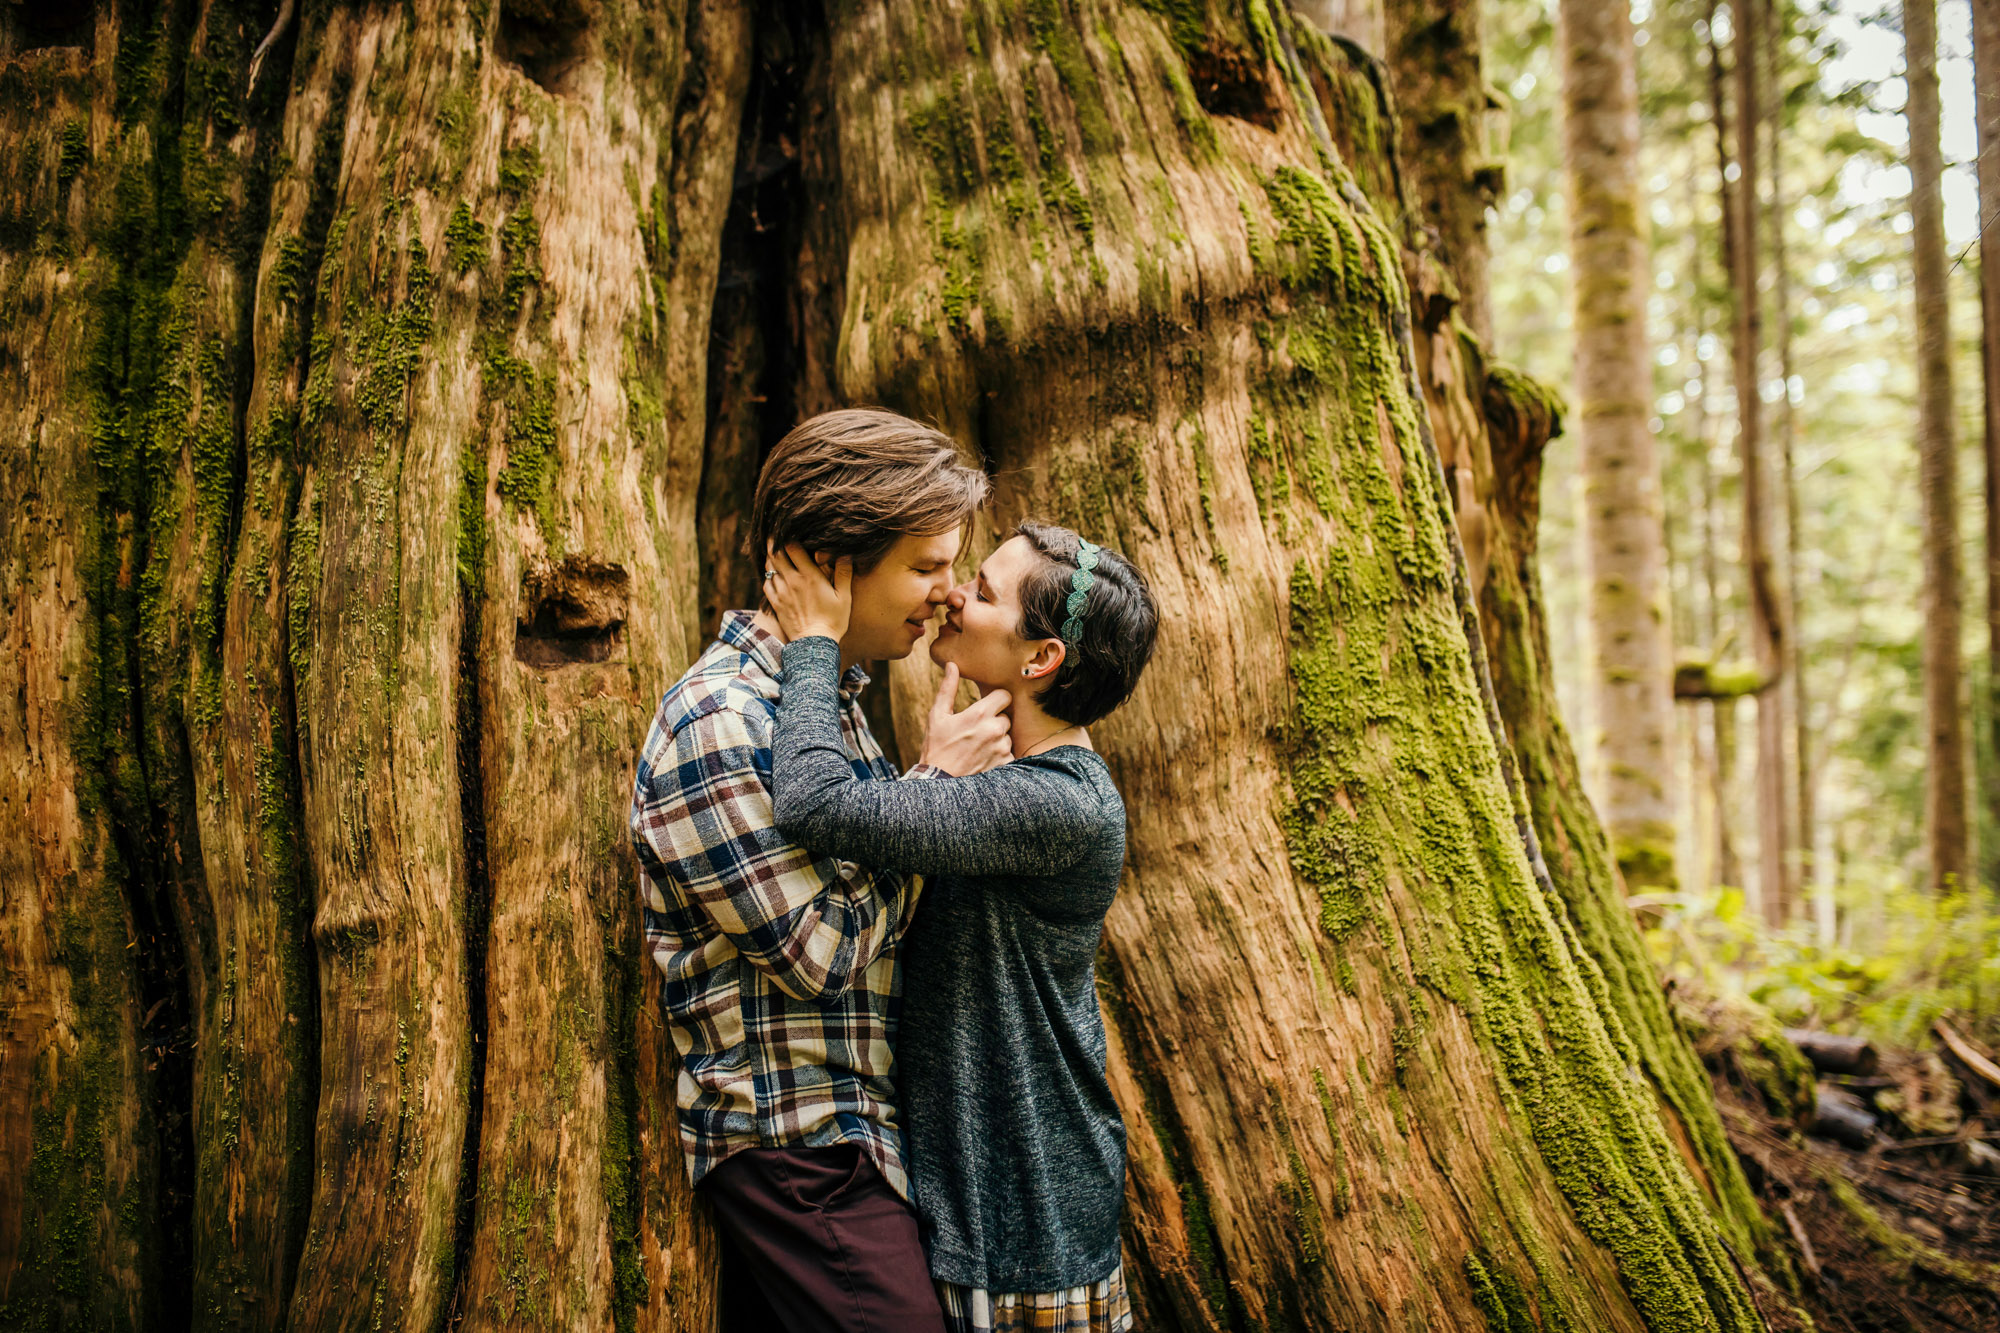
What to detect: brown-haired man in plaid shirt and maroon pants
<box><xmin>632</xmin><ymin>408</ymin><xmax>1010</xmax><ymax>1331</ymax></box>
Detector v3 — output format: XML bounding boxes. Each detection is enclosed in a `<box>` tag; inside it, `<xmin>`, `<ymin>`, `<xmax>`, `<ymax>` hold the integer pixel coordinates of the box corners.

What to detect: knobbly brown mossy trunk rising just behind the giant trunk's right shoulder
<box><xmin>1384</xmin><ymin>0</ymin><xmax>1506</xmax><ymax>346</ymax></box>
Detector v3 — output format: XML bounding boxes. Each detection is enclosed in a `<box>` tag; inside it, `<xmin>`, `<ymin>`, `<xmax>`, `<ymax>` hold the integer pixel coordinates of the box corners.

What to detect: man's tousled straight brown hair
<box><xmin>744</xmin><ymin>408</ymin><xmax>990</xmax><ymax>574</ymax></box>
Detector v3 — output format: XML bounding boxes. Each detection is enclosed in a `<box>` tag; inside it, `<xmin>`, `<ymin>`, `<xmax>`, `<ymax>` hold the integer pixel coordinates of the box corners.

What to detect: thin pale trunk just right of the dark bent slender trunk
<box><xmin>1760</xmin><ymin>0</ymin><xmax>1818</xmax><ymax>917</ymax></box>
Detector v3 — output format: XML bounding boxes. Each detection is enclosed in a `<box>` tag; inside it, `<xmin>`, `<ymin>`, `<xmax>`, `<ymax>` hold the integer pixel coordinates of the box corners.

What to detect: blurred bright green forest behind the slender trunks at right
<box><xmin>1488</xmin><ymin>0</ymin><xmax>2000</xmax><ymax>1041</ymax></box>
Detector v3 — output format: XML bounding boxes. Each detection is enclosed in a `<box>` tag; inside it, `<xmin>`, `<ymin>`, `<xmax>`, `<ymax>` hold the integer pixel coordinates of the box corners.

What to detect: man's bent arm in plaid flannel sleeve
<box><xmin>632</xmin><ymin>709</ymin><xmax>908</xmax><ymax>1003</ymax></box>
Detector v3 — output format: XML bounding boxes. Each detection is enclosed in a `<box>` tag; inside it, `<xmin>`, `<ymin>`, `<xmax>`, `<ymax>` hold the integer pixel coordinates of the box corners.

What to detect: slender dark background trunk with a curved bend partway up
<box><xmin>1730</xmin><ymin>0</ymin><xmax>1792</xmax><ymax>927</ymax></box>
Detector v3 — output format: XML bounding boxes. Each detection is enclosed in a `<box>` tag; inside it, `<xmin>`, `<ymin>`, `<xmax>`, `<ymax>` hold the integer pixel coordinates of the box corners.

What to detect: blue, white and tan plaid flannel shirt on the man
<box><xmin>632</xmin><ymin>610</ymin><xmax>928</xmax><ymax>1197</ymax></box>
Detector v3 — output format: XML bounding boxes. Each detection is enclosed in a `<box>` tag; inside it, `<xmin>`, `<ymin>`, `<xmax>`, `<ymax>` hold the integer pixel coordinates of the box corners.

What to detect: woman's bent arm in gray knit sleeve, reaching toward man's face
<box><xmin>772</xmin><ymin>636</ymin><xmax>1102</xmax><ymax>875</ymax></box>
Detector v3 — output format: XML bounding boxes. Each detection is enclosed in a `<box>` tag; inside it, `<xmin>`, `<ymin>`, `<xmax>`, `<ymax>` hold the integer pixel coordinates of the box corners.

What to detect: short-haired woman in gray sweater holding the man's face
<box><xmin>764</xmin><ymin>522</ymin><xmax>1158</xmax><ymax>1333</ymax></box>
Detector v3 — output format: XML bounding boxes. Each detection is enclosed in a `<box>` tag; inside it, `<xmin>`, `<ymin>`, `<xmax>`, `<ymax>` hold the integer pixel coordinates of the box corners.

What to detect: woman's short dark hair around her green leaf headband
<box><xmin>1014</xmin><ymin>518</ymin><xmax>1160</xmax><ymax>727</ymax></box>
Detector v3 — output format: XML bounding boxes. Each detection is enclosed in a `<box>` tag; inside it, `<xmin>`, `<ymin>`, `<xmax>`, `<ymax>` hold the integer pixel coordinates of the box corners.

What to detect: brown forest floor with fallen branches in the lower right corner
<box><xmin>1698</xmin><ymin>1008</ymin><xmax>2000</xmax><ymax>1333</ymax></box>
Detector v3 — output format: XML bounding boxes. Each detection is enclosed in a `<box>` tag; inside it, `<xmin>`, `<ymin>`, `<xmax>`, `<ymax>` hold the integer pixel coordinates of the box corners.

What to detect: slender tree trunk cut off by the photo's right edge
<box><xmin>1972</xmin><ymin>0</ymin><xmax>2000</xmax><ymax>887</ymax></box>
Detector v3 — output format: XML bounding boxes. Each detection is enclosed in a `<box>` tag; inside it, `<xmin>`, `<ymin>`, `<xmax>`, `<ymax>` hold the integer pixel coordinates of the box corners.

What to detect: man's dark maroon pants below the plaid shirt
<box><xmin>702</xmin><ymin>1143</ymin><xmax>944</xmax><ymax>1333</ymax></box>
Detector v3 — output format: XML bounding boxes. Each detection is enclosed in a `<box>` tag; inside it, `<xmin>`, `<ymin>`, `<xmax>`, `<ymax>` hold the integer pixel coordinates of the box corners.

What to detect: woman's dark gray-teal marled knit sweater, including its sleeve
<box><xmin>772</xmin><ymin>638</ymin><xmax>1124</xmax><ymax>1291</ymax></box>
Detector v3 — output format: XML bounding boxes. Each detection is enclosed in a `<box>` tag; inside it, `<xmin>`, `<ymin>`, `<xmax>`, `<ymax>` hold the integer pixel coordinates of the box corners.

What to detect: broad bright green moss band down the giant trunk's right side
<box><xmin>1254</xmin><ymin>145</ymin><xmax>1756</xmax><ymax>1331</ymax></box>
